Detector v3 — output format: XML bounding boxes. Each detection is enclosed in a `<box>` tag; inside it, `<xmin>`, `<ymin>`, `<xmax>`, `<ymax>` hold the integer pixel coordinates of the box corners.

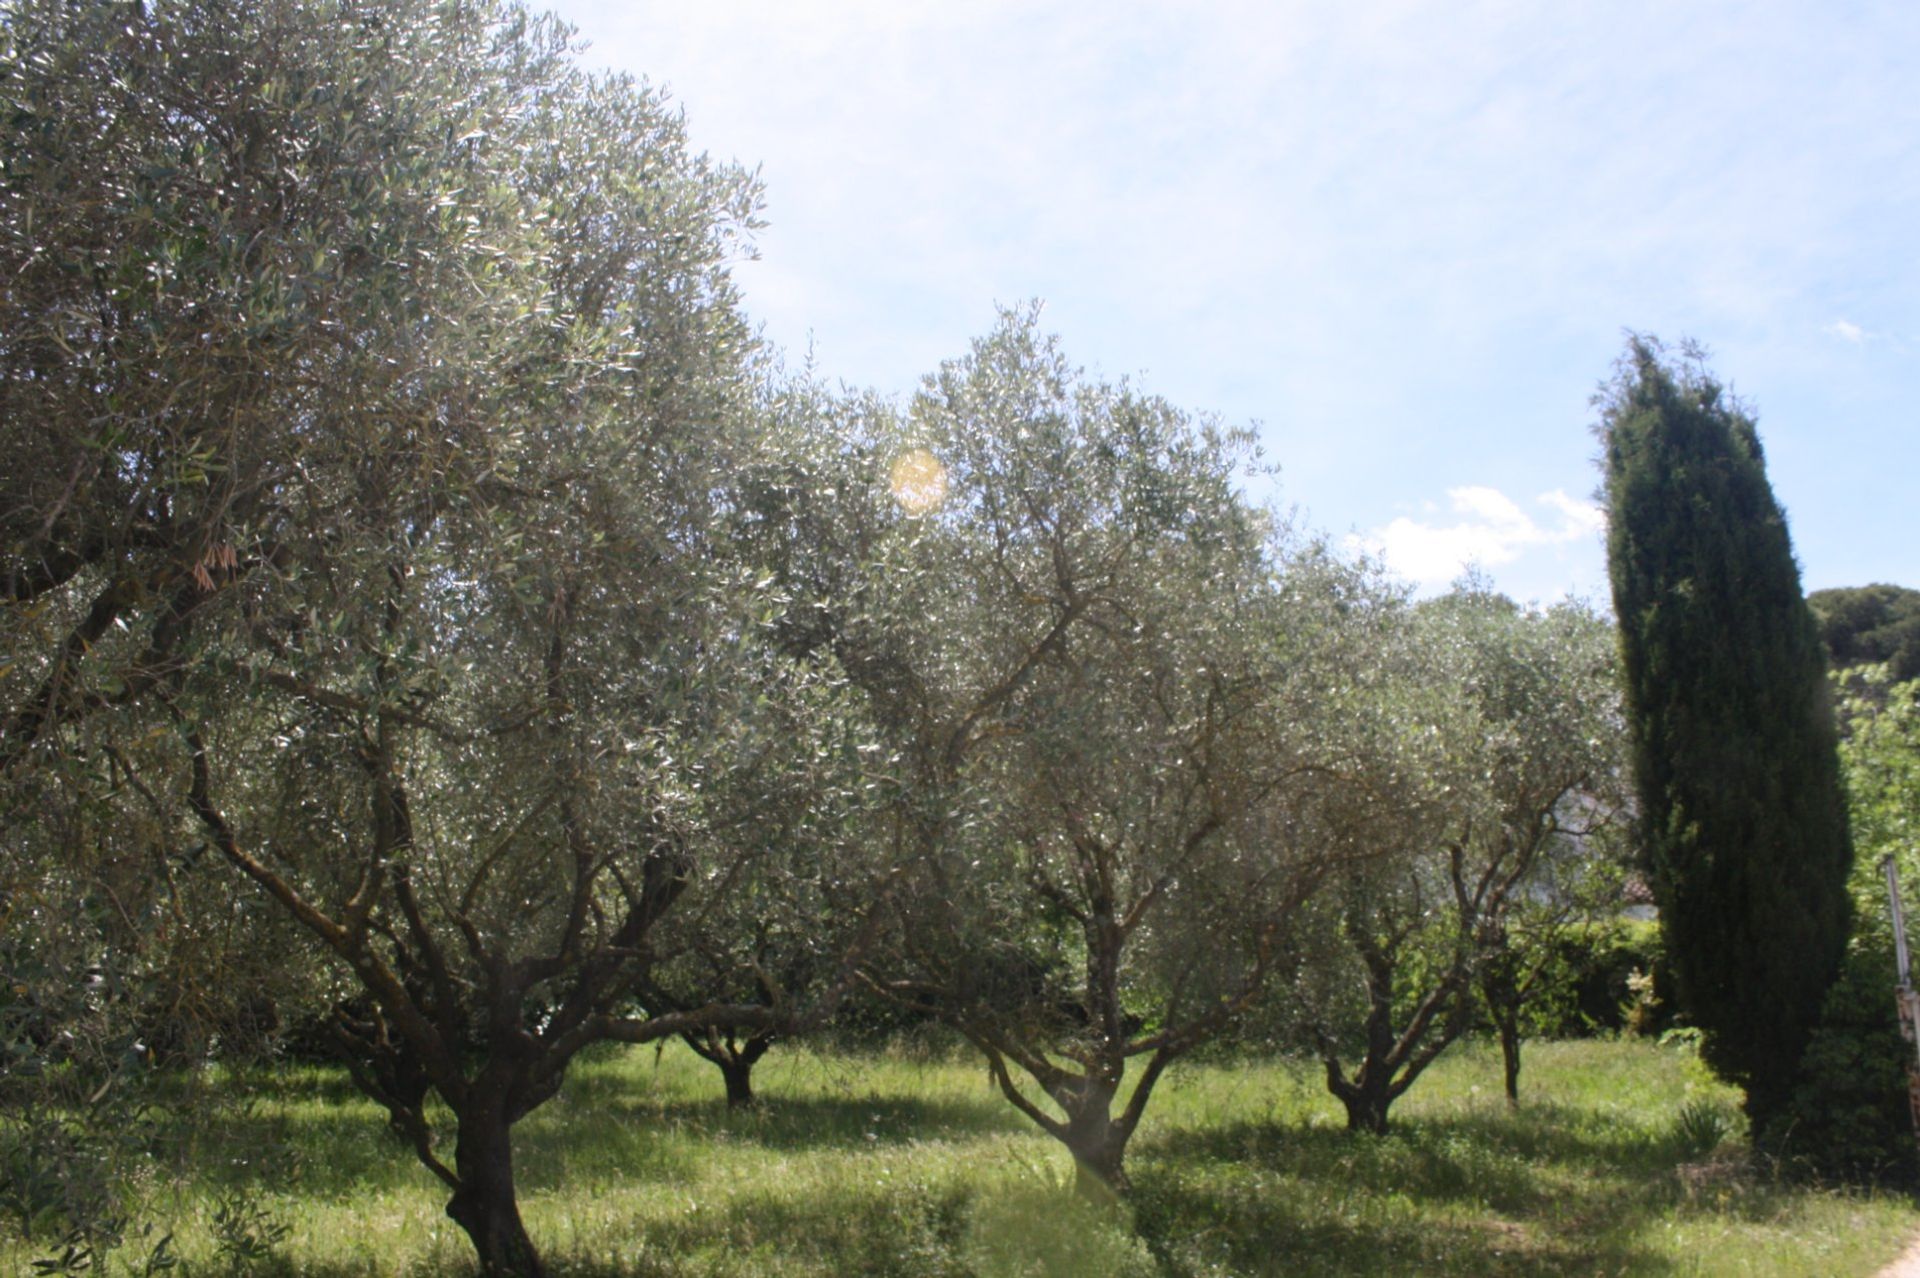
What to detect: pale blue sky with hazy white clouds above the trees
<box><xmin>559</xmin><ymin>0</ymin><xmax>1920</xmax><ymax>599</ymax></box>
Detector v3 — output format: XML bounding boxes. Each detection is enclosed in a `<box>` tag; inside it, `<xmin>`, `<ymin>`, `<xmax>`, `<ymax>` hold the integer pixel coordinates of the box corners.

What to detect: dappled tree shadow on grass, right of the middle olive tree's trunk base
<box><xmin>1137</xmin><ymin>1107</ymin><xmax>1722</xmax><ymax>1274</ymax></box>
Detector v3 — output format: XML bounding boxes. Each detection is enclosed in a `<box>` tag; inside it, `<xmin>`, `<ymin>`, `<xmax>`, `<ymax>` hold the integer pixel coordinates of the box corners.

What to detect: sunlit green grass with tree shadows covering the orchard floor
<box><xmin>0</xmin><ymin>1042</ymin><xmax>1920</xmax><ymax>1278</ymax></box>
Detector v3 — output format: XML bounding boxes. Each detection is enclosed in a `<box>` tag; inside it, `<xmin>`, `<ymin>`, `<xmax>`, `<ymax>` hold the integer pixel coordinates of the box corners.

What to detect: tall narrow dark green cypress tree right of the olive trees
<box><xmin>1597</xmin><ymin>336</ymin><xmax>1853</xmax><ymax>1132</ymax></box>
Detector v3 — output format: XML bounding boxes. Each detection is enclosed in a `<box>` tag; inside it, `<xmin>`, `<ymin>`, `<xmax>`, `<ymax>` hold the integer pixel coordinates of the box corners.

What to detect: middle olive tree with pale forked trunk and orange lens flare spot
<box><xmin>772</xmin><ymin>313</ymin><xmax>1397</xmax><ymax>1188</ymax></box>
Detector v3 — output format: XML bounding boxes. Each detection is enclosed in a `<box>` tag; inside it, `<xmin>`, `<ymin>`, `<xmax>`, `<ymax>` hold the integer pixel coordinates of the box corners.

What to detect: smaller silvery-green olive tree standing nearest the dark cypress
<box><xmin>1315</xmin><ymin>581</ymin><xmax>1624</xmax><ymax>1132</ymax></box>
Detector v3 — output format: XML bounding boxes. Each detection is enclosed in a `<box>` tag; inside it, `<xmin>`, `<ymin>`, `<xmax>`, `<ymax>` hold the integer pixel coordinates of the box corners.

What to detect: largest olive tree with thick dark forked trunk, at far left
<box><xmin>0</xmin><ymin>0</ymin><xmax>864</xmax><ymax>1274</ymax></box>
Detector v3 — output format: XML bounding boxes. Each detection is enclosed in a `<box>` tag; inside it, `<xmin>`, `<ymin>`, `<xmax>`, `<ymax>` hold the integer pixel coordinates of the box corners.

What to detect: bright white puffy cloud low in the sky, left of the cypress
<box><xmin>1348</xmin><ymin>485</ymin><xmax>1607</xmax><ymax>589</ymax></box>
